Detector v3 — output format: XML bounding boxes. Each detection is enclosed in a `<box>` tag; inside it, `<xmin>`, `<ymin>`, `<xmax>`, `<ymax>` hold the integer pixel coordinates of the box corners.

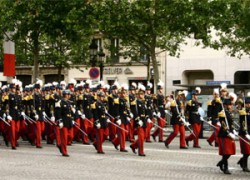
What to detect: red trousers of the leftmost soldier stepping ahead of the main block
<box><xmin>61</xmin><ymin>127</ymin><xmax>73</xmax><ymax>155</ymax></box>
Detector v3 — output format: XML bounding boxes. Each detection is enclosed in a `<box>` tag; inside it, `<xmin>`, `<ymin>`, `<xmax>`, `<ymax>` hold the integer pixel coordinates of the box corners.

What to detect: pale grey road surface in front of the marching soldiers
<box><xmin>0</xmin><ymin>131</ymin><xmax>250</xmax><ymax>180</ymax></box>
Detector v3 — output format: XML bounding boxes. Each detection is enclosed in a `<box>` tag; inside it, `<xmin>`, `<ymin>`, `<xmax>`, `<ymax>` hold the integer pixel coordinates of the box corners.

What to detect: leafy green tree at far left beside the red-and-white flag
<box><xmin>0</xmin><ymin>0</ymin><xmax>95</xmax><ymax>82</ymax></box>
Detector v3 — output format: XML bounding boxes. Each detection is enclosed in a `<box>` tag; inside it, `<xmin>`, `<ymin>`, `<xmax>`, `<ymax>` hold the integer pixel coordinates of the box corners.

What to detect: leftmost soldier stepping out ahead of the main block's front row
<box><xmin>58</xmin><ymin>90</ymin><xmax>74</xmax><ymax>157</ymax></box>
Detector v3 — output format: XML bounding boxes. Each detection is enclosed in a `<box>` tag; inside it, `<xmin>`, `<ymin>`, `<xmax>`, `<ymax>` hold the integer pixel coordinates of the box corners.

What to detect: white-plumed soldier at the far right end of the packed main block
<box><xmin>152</xmin><ymin>81</ymin><xmax>166</xmax><ymax>142</ymax></box>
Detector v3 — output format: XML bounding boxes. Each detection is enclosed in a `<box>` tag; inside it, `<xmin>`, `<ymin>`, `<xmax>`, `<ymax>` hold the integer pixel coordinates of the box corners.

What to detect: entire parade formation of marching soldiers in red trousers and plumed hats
<box><xmin>0</xmin><ymin>79</ymin><xmax>250</xmax><ymax>174</ymax></box>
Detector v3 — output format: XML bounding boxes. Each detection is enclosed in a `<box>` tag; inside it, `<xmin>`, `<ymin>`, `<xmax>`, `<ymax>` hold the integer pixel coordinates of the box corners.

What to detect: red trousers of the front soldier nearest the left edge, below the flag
<box><xmin>7</xmin><ymin>120</ymin><xmax>20</xmax><ymax>148</ymax></box>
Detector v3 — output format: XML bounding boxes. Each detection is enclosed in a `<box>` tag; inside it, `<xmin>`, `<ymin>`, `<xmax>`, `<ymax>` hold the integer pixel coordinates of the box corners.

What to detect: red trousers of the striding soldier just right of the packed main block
<box><xmin>166</xmin><ymin>124</ymin><xmax>186</xmax><ymax>147</ymax></box>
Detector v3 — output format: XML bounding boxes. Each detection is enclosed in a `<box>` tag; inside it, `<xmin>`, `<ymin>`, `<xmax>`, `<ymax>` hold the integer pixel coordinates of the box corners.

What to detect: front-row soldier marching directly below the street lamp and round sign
<box><xmin>93</xmin><ymin>91</ymin><xmax>110</xmax><ymax>154</ymax></box>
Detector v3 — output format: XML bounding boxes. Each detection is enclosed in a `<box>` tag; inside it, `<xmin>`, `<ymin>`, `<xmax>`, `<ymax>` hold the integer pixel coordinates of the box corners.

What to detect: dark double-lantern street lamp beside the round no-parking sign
<box><xmin>89</xmin><ymin>39</ymin><xmax>105</xmax><ymax>81</ymax></box>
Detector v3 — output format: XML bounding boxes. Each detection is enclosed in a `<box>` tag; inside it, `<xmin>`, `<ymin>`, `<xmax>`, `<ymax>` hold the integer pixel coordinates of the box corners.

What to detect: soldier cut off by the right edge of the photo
<box><xmin>238</xmin><ymin>94</ymin><xmax>250</xmax><ymax>172</ymax></box>
